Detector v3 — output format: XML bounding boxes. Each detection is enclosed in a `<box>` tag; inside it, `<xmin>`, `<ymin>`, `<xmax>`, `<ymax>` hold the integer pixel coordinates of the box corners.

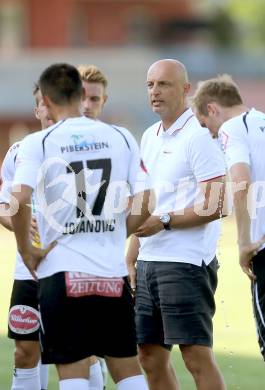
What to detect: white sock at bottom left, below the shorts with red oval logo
<box><xmin>11</xmin><ymin>366</ymin><xmax>40</xmax><ymax>390</ymax></box>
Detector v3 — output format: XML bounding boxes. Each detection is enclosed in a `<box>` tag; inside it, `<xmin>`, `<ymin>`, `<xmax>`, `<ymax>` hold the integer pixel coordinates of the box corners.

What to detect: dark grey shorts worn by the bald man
<box><xmin>136</xmin><ymin>258</ymin><xmax>219</xmax><ymax>349</ymax></box>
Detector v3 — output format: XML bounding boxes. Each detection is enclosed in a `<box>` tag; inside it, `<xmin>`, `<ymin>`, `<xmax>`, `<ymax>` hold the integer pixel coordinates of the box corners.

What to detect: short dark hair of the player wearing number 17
<box><xmin>38</xmin><ymin>63</ymin><xmax>82</xmax><ymax>105</ymax></box>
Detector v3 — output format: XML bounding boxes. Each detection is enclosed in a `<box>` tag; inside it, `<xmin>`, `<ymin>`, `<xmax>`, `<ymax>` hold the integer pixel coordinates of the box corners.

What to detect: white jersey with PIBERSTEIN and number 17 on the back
<box><xmin>14</xmin><ymin>117</ymin><xmax>143</xmax><ymax>278</ymax></box>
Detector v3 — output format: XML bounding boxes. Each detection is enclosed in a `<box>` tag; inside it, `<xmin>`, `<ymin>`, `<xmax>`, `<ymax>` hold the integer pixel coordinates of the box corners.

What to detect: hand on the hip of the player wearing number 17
<box><xmin>21</xmin><ymin>241</ymin><xmax>57</xmax><ymax>280</ymax></box>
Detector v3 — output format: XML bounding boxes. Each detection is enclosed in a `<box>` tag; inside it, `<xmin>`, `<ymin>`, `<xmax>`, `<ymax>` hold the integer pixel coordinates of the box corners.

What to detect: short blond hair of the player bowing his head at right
<box><xmin>191</xmin><ymin>74</ymin><xmax>242</xmax><ymax>116</ymax></box>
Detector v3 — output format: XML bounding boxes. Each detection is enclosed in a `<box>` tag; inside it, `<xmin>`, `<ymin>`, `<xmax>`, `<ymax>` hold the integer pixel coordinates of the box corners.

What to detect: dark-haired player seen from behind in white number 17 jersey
<box><xmin>12</xmin><ymin>64</ymin><xmax>149</xmax><ymax>390</ymax></box>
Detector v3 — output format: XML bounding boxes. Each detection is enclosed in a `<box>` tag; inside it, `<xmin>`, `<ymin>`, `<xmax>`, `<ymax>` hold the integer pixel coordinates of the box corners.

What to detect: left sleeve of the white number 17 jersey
<box><xmin>13</xmin><ymin>132</ymin><xmax>43</xmax><ymax>189</ymax></box>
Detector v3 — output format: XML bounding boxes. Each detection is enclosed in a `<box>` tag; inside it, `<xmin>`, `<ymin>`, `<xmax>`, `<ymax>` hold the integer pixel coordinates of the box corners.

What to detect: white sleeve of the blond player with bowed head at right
<box><xmin>219</xmin><ymin>116</ymin><xmax>250</xmax><ymax>169</ymax></box>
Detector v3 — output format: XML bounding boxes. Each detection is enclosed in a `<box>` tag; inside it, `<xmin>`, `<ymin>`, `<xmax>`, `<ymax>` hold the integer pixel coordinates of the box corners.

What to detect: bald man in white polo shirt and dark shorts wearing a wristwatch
<box><xmin>127</xmin><ymin>59</ymin><xmax>225</xmax><ymax>390</ymax></box>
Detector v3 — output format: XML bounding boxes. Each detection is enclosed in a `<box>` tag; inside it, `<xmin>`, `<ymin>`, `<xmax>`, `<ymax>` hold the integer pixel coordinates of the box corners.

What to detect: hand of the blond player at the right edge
<box><xmin>239</xmin><ymin>236</ymin><xmax>265</xmax><ymax>280</ymax></box>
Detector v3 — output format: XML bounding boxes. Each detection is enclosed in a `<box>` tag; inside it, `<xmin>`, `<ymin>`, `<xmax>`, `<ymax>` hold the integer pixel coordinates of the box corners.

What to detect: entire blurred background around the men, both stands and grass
<box><xmin>0</xmin><ymin>0</ymin><xmax>265</xmax><ymax>390</ymax></box>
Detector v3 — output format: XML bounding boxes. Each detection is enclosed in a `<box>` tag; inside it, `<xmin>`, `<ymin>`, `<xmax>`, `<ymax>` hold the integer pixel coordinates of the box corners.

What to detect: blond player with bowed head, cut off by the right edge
<box><xmin>193</xmin><ymin>75</ymin><xmax>265</xmax><ymax>358</ymax></box>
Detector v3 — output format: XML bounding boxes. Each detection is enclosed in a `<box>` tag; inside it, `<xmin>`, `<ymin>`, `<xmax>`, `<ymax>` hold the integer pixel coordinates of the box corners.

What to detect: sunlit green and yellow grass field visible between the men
<box><xmin>0</xmin><ymin>218</ymin><xmax>265</xmax><ymax>390</ymax></box>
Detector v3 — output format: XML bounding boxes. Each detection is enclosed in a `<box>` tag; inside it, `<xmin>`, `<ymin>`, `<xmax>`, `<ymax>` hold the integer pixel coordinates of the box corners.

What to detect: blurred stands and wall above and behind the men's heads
<box><xmin>0</xmin><ymin>0</ymin><xmax>265</xmax><ymax>161</ymax></box>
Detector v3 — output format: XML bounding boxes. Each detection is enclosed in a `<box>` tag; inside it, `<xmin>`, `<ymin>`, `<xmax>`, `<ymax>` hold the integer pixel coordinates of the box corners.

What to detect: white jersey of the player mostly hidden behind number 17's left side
<box><xmin>0</xmin><ymin>142</ymin><xmax>32</xmax><ymax>280</ymax></box>
